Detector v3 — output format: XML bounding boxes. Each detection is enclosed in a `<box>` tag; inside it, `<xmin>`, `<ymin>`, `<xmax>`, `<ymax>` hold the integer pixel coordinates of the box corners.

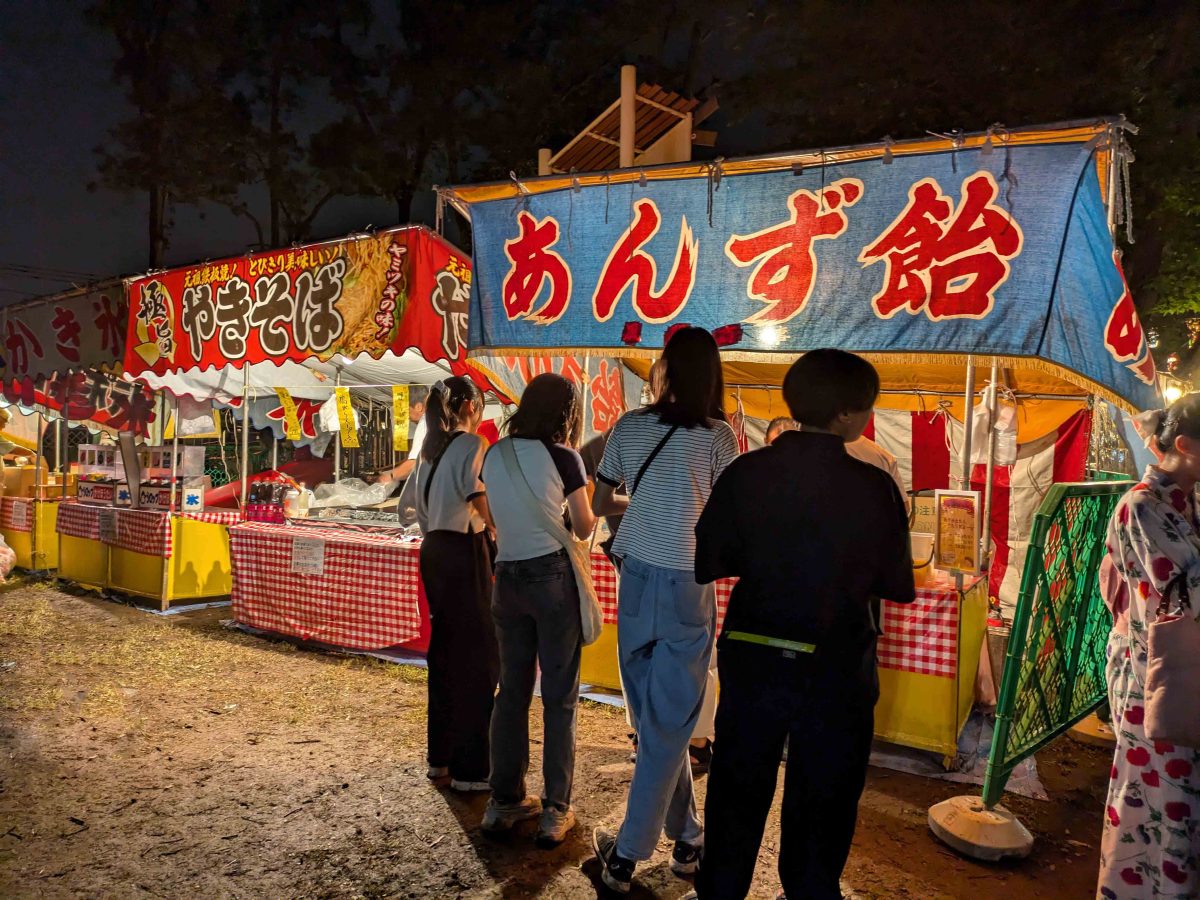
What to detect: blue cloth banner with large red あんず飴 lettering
<box><xmin>470</xmin><ymin>143</ymin><xmax>1156</xmax><ymax>408</ymax></box>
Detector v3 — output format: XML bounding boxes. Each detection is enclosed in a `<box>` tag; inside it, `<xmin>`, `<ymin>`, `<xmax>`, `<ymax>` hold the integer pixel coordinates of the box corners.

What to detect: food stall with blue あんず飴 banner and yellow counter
<box><xmin>442</xmin><ymin>120</ymin><xmax>1156</xmax><ymax>755</ymax></box>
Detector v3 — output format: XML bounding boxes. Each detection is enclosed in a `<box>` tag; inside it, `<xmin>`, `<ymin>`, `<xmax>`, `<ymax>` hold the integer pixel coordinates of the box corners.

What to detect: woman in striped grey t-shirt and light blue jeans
<box><xmin>592</xmin><ymin>328</ymin><xmax>738</xmax><ymax>893</ymax></box>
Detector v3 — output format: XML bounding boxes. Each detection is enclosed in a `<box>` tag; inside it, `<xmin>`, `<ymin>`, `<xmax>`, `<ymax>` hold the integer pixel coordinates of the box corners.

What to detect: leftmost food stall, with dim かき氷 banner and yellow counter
<box><xmin>0</xmin><ymin>281</ymin><xmax>145</xmax><ymax>571</ymax></box>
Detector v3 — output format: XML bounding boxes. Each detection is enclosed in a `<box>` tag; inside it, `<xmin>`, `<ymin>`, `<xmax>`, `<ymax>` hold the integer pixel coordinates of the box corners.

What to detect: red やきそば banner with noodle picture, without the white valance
<box><xmin>125</xmin><ymin>227</ymin><xmax>473</xmax><ymax>386</ymax></box>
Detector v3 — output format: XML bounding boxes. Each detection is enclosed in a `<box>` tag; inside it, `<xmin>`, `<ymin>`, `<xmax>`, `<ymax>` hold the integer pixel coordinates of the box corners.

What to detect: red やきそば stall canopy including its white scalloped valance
<box><xmin>118</xmin><ymin>226</ymin><xmax>501</xmax><ymax>402</ymax></box>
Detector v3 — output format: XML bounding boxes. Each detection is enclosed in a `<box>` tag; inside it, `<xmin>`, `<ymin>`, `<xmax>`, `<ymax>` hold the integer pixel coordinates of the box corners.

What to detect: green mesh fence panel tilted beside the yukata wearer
<box><xmin>983</xmin><ymin>480</ymin><xmax>1133</xmax><ymax>806</ymax></box>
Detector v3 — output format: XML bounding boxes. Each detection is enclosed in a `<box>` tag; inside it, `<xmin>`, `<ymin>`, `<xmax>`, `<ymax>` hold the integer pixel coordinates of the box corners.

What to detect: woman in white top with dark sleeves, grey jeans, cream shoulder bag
<box><xmin>472</xmin><ymin>373</ymin><xmax>595</xmax><ymax>846</ymax></box>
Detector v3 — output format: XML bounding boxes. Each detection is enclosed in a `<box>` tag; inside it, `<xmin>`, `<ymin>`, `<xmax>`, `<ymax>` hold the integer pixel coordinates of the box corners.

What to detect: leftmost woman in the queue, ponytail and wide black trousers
<box><xmin>416</xmin><ymin>376</ymin><xmax>499</xmax><ymax>791</ymax></box>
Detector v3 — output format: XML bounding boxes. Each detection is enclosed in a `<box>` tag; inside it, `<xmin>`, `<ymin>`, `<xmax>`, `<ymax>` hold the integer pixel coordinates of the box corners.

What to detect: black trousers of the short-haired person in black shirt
<box><xmin>696</xmin><ymin>637</ymin><xmax>878</xmax><ymax>900</ymax></box>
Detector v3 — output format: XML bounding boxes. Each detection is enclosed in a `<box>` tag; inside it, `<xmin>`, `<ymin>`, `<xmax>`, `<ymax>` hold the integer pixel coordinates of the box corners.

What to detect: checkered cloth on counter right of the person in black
<box><xmin>877</xmin><ymin>580</ymin><xmax>978</xmax><ymax>678</ymax></box>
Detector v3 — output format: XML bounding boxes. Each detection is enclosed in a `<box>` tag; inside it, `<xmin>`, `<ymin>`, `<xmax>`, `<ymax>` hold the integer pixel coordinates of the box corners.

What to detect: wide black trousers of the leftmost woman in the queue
<box><xmin>421</xmin><ymin>532</ymin><xmax>500</xmax><ymax>781</ymax></box>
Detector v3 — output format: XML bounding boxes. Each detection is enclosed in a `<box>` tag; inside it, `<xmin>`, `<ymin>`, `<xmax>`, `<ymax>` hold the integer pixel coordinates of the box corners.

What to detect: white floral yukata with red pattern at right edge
<box><xmin>1097</xmin><ymin>466</ymin><xmax>1200</xmax><ymax>900</ymax></box>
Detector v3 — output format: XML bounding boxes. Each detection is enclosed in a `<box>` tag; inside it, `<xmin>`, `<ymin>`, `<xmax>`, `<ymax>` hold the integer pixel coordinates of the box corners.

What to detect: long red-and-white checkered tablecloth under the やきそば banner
<box><xmin>229</xmin><ymin>522</ymin><xmax>421</xmax><ymax>650</ymax></box>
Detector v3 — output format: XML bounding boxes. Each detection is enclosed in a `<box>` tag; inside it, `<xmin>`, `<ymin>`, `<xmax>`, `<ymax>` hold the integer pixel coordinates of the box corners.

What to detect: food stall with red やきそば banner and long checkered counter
<box><xmin>126</xmin><ymin>227</ymin><xmax>508</xmax><ymax>628</ymax></box>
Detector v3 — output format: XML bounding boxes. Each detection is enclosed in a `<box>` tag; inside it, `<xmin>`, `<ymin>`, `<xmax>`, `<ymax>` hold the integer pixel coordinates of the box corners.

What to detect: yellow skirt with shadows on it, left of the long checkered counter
<box><xmin>108</xmin><ymin>516</ymin><xmax>233</xmax><ymax>610</ymax></box>
